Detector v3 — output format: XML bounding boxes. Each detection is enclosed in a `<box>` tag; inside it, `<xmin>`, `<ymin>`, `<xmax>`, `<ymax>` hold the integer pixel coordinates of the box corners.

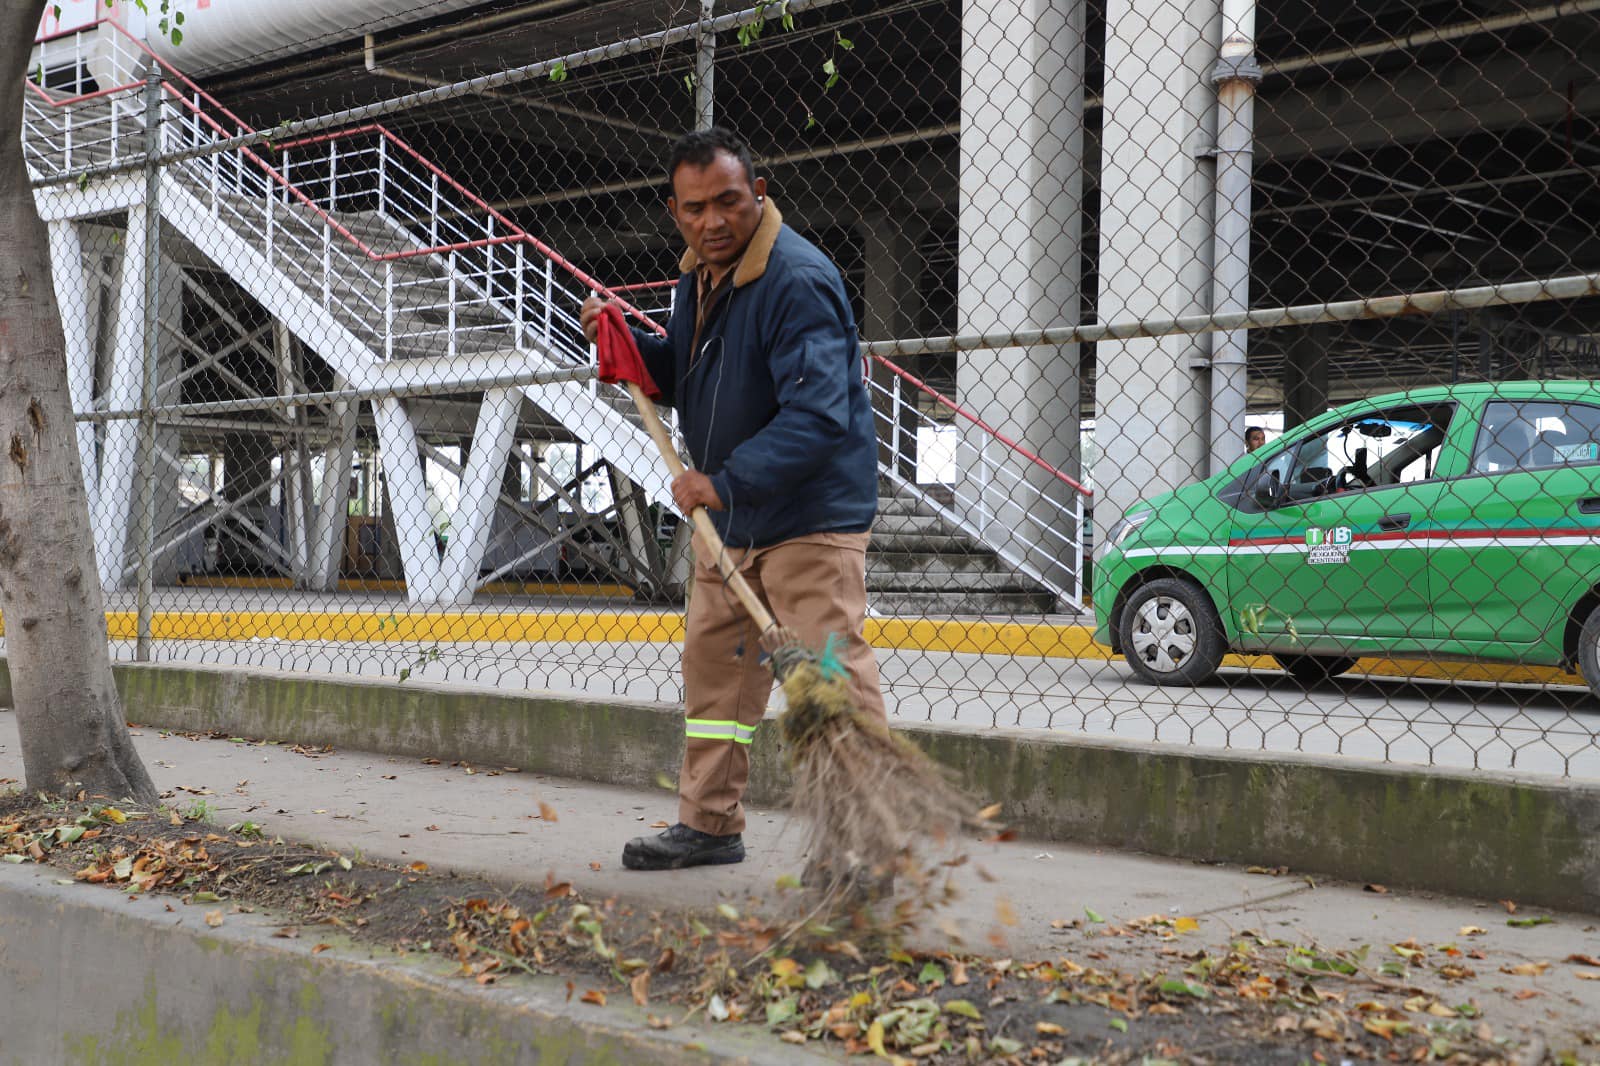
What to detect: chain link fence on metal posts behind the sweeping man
<box><xmin>24</xmin><ymin>0</ymin><xmax>1600</xmax><ymax>778</ymax></box>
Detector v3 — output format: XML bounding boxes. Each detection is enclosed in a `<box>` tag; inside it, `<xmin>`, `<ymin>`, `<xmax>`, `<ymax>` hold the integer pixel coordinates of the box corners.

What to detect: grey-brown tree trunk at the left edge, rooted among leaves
<box><xmin>0</xmin><ymin>0</ymin><xmax>157</xmax><ymax>805</ymax></box>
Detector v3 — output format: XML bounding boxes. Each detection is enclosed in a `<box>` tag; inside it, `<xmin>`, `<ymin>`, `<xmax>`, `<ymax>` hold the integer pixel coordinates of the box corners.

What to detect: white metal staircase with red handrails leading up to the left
<box><xmin>26</xmin><ymin>21</ymin><xmax>1082</xmax><ymax>613</ymax></box>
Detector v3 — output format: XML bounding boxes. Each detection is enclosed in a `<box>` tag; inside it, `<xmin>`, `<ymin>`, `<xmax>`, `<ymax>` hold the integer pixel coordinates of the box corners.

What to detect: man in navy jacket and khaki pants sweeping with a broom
<box><xmin>582</xmin><ymin>128</ymin><xmax>885</xmax><ymax>869</ymax></box>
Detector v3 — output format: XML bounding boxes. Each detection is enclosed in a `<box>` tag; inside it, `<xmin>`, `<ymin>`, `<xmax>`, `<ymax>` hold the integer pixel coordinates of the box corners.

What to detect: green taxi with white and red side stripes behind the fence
<box><xmin>1094</xmin><ymin>381</ymin><xmax>1600</xmax><ymax>695</ymax></box>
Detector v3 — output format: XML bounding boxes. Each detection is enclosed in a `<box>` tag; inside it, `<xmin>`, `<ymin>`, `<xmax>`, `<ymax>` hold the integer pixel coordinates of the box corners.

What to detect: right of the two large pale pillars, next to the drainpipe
<box><xmin>1094</xmin><ymin>0</ymin><xmax>1216</xmax><ymax>530</ymax></box>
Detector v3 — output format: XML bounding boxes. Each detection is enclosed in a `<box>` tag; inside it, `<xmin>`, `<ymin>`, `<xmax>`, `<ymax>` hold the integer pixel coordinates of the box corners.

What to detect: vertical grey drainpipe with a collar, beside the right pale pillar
<box><xmin>1211</xmin><ymin>0</ymin><xmax>1261</xmax><ymax>474</ymax></box>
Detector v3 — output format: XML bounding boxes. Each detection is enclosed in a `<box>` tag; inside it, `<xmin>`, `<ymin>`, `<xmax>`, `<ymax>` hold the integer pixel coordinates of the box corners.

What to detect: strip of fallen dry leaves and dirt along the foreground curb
<box><xmin>0</xmin><ymin>797</ymin><xmax>1542</xmax><ymax>1064</ymax></box>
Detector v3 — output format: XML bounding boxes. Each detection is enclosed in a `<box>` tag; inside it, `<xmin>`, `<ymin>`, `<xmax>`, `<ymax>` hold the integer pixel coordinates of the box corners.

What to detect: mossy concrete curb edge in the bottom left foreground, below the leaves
<box><xmin>0</xmin><ymin>866</ymin><xmax>837</xmax><ymax>1066</ymax></box>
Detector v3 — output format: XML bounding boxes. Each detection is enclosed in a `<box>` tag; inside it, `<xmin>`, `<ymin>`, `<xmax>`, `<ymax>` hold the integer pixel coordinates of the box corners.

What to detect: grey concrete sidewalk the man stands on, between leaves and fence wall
<box><xmin>0</xmin><ymin>712</ymin><xmax>1600</xmax><ymax>1047</ymax></box>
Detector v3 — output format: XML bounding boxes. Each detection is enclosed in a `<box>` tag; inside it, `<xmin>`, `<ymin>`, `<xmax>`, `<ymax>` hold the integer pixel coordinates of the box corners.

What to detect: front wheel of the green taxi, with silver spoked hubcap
<box><xmin>1120</xmin><ymin>578</ymin><xmax>1227</xmax><ymax>685</ymax></box>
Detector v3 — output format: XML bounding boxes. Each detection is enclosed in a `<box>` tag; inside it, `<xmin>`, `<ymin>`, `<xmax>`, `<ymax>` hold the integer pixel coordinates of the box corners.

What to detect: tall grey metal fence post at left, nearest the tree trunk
<box><xmin>132</xmin><ymin>59</ymin><xmax>162</xmax><ymax>663</ymax></box>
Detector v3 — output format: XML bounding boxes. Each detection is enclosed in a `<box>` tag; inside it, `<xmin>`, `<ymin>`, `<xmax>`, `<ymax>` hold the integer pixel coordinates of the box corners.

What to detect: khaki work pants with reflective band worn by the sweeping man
<box><xmin>678</xmin><ymin>533</ymin><xmax>885</xmax><ymax>836</ymax></box>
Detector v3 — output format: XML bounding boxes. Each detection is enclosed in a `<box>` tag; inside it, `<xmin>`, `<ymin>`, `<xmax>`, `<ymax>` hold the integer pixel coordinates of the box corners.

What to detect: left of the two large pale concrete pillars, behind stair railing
<box><xmin>957</xmin><ymin>0</ymin><xmax>1085</xmax><ymax>579</ymax></box>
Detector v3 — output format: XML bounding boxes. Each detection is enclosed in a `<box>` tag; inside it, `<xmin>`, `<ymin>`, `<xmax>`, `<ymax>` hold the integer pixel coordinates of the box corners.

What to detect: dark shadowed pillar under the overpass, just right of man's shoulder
<box><xmin>861</xmin><ymin>205</ymin><xmax>928</xmax><ymax>479</ymax></box>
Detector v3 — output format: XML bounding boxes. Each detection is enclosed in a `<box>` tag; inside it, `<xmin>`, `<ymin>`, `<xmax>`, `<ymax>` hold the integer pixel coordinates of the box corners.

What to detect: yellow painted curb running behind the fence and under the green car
<box><xmin>0</xmin><ymin>610</ymin><xmax>1584</xmax><ymax>685</ymax></box>
